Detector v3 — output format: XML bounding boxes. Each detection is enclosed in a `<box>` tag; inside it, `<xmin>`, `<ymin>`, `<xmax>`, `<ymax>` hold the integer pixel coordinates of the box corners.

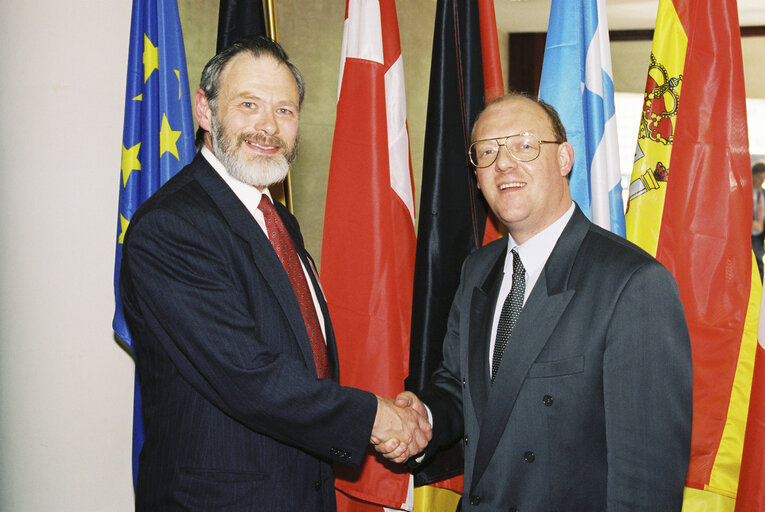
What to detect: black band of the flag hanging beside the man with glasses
<box><xmin>406</xmin><ymin>0</ymin><xmax>487</xmax><ymax>490</ymax></box>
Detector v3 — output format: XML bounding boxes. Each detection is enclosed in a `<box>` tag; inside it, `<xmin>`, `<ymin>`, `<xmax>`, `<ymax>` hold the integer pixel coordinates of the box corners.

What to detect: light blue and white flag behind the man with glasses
<box><xmin>539</xmin><ymin>0</ymin><xmax>625</xmax><ymax>236</ymax></box>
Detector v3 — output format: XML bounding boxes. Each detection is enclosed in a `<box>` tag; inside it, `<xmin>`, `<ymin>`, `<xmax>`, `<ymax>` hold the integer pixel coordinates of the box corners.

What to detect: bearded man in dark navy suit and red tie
<box><xmin>120</xmin><ymin>37</ymin><xmax>430</xmax><ymax>511</ymax></box>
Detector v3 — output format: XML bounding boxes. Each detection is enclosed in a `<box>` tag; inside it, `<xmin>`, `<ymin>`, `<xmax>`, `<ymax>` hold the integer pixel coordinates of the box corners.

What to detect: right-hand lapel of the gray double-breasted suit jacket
<box><xmin>472</xmin><ymin>206</ymin><xmax>590</xmax><ymax>494</ymax></box>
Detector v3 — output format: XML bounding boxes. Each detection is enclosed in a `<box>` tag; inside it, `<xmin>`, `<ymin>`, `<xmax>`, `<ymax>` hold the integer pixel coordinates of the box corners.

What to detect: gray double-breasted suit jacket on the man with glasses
<box><xmin>421</xmin><ymin>208</ymin><xmax>692</xmax><ymax>512</ymax></box>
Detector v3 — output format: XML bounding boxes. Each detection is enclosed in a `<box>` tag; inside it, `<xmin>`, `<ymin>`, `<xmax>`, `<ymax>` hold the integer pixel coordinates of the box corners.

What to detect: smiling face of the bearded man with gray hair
<box><xmin>195</xmin><ymin>53</ymin><xmax>300</xmax><ymax>190</ymax></box>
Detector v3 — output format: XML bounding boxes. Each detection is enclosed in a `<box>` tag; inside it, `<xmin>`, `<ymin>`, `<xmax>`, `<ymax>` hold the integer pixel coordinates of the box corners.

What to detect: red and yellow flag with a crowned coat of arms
<box><xmin>626</xmin><ymin>0</ymin><xmax>761</xmax><ymax>511</ymax></box>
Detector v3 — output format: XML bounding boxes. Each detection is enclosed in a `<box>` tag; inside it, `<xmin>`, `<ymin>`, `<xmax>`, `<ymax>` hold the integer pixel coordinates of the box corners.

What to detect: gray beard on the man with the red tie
<box><xmin>211</xmin><ymin>116</ymin><xmax>290</xmax><ymax>189</ymax></box>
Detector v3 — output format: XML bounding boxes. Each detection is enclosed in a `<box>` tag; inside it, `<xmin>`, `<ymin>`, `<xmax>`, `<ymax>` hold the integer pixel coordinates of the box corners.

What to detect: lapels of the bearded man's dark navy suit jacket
<box><xmin>193</xmin><ymin>154</ymin><xmax>320</xmax><ymax>375</ymax></box>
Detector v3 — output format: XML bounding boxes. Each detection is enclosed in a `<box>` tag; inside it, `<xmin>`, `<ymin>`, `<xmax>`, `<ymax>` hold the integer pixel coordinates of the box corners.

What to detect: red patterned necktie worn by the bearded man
<box><xmin>258</xmin><ymin>194</ymin><xmax>330</xmax><ymax>379</ymax></box>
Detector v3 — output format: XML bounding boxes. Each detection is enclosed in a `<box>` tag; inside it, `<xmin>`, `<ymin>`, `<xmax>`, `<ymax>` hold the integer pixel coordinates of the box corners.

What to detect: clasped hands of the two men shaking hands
<box><xmin>369</xmin><ymin>391</ymin><xmax>433</xmax><ymax>463</ymax></box>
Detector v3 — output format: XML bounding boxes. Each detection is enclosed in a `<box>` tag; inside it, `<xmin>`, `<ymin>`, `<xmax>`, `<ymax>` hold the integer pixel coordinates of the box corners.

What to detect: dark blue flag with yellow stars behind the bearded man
<box><xmin>112</xmin><ymin>0</ymin><xmax>195</xmax><ymax>483</ymax></box>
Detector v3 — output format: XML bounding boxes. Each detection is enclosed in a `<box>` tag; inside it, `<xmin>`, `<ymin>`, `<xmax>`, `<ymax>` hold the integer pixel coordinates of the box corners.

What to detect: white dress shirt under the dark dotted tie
<box><xmin>489</xmin><ymin>201</ymin><xmax>574</xmax><ymax>375</ymax></box>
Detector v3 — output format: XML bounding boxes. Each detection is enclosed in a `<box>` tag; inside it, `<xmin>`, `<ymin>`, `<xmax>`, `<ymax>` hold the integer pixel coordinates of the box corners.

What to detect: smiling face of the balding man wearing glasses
<box><xmin>472</xmin><ymin>97</ymin><xmax>574</xmax><ymax>248</ymax></box>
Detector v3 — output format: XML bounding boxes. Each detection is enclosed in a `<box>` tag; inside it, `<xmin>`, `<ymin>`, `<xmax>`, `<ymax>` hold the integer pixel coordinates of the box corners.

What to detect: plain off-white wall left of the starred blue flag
<box><xmin>0</xmin><ymin>0</ymin><xmax>134</xmax><ymax>512</ymax></box>
